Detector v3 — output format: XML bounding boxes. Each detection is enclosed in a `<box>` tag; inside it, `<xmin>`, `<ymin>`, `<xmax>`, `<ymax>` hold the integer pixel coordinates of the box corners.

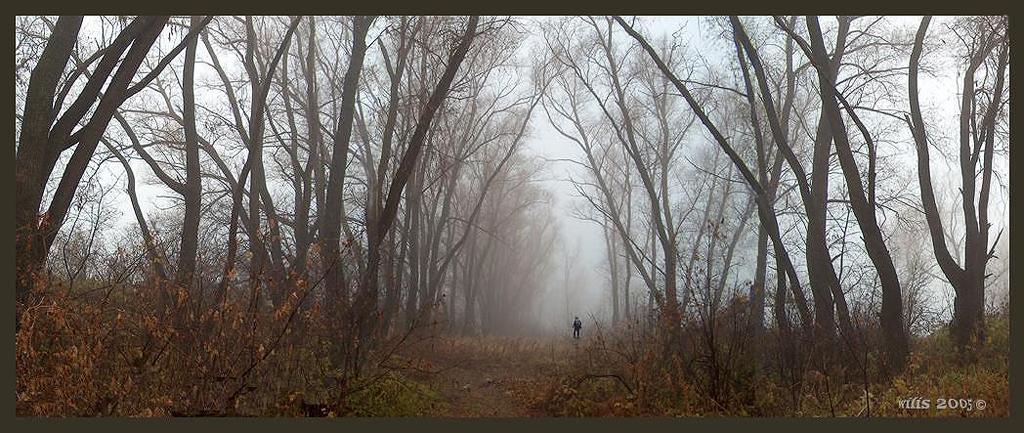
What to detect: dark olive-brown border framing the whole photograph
<box><xmin>0</xmin><ymin>0</ymin><xmax>1024</xmax><ymax>433</ymax></box>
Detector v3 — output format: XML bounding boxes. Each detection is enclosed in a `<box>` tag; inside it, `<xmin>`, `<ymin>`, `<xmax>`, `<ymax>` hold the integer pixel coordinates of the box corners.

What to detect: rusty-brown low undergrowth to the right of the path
<box><xmin>537</xmin><ymin>313</ymin><xmax>1010</xmax><ymax>417</ymax></box>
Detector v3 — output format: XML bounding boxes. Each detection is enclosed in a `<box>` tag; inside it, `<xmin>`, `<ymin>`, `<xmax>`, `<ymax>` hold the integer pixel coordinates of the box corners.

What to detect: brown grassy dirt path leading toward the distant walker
<box><xmin>399</xmin><ymin>337</ymin><xmax>574</xmax><ymax>418</ymax></box>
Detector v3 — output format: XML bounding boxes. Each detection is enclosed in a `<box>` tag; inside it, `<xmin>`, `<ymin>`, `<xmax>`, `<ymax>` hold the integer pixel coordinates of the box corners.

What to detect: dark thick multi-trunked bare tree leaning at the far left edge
<box><xmin>15</xmin><ymin>16</ymin><xmax>209</xmax><ymax>321</ymax></box>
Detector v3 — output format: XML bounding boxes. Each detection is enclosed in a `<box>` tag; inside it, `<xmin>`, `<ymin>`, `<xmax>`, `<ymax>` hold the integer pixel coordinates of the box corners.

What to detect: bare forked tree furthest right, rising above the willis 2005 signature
<box><xmin>907</xmin><ymin>16</ymin><xmax>1010</xmax><ymax>349</ymax></box>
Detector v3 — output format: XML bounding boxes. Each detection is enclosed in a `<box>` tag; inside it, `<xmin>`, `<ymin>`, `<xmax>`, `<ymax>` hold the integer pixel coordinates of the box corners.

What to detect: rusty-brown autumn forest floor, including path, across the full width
<box><xmin>16</xmin><ymin>282</ymin><xmax>1010</xmax><ymax>417</ymax></box>
